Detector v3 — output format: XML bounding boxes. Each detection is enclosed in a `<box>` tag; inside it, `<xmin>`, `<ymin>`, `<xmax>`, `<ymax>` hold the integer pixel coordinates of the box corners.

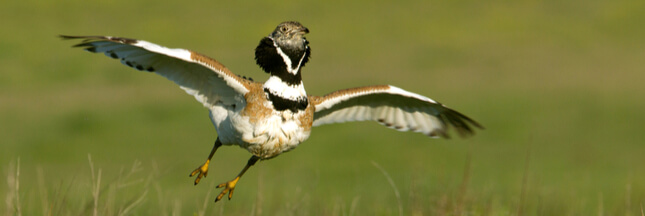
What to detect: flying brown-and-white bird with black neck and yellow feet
<box><xmin>60</xmin><ymin>21</ymin><xmax>483</xmax><ymax>202</ymax></box>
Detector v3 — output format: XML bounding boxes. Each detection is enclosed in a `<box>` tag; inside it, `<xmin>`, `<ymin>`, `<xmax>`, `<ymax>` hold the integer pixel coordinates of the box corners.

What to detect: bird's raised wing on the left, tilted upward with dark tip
<box><xmin>61</xmin><ymin>35</ymin><xmax>251</xmax><ymax>107</ymax></box>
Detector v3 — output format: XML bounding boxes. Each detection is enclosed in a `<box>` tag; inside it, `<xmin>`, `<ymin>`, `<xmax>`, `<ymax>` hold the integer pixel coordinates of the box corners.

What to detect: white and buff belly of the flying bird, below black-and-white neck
<box><xmin>213</xmin><ymin>109</ymin><xmax>311</xmax><ymax>159</ymax></box>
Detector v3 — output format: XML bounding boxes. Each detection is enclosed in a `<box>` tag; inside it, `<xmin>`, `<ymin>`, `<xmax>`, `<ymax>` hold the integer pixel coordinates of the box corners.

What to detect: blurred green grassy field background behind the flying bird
<box><xmin>0</xmin><ymin>0</ymin><xmax>645</xmax><ymax>215</ymax></box>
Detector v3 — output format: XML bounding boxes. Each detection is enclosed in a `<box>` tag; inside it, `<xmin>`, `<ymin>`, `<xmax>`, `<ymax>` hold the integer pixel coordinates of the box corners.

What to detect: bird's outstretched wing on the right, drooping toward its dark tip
<box><xmin>310</xmin><ymin>85</ymin><xmax>482</xmax><ymax>138</ymax></box>
